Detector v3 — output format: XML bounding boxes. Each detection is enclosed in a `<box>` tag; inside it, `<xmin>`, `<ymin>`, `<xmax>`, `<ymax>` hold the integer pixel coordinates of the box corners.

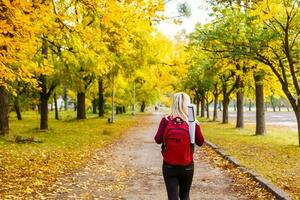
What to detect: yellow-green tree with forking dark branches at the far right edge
<box><xmin>229</xmin><ymin>0</ymin><xmax>300</xmax><ymax>144</ymax></box>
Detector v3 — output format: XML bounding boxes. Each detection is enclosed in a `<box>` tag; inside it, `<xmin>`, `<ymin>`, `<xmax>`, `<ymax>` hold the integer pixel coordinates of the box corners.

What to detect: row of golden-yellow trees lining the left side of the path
<box><xmin>0</xmin><ymin>0</ymin><xmax>186</xmax><ymax>134</ymax></box>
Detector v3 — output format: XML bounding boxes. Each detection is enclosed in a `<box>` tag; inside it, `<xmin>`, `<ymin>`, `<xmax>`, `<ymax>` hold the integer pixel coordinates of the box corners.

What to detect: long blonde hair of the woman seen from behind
<box><xmin>171</xmin><ymin>92</ymin><xmax>191</xmax><ymax>122</ymax></box>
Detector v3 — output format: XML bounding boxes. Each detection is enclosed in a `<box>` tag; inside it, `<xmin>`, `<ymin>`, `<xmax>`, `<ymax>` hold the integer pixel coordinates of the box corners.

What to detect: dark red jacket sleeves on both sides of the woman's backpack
<box><xmin>154</xmin><ymin>117</ymin><xmax>204</xmax><ymax>146</ymax></box>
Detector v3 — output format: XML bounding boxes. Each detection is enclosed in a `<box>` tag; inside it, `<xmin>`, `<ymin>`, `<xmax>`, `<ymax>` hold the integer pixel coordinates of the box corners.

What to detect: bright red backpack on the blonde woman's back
<box><xmin>162</xmin><ymin>117</ymin><xmax>193</xmax><ymax>166</ymax></box>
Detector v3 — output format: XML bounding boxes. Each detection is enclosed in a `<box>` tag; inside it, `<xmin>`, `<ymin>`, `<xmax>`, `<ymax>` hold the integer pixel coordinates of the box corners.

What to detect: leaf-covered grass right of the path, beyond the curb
<box><xmin>201</xmin><ymin>119</ymin><xmax>300</xmax><ymax>199</ymax></box>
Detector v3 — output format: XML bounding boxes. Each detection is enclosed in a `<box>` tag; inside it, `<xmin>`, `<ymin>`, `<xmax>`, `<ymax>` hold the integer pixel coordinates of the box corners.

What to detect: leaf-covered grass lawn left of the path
<box><xmin>0</xmin><ymin>111</ymin><xmax>138</xmax><ymax>199</ymax></box>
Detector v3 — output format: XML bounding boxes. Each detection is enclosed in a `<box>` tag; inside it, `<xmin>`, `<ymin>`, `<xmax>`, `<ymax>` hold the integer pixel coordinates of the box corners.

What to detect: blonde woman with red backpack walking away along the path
<box><xmin>155</xmin><ymin>92</ymin><xmax>204</xmax><ymax>200</ymax></box>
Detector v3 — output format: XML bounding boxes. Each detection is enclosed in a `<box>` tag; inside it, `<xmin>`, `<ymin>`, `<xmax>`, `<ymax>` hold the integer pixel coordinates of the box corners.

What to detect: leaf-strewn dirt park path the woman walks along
<box><xmin>48</xmin><ymin>114</ymin><xmax>256</xmax><ymax>200</ymax></box>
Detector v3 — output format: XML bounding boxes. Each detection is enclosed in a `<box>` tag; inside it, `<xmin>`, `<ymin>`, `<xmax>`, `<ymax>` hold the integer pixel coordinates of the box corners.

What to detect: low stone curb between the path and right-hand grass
<box><xmin>205</xmin><ymin>140</ymin><xmax>292</xmax><ymax>200</ymax></box>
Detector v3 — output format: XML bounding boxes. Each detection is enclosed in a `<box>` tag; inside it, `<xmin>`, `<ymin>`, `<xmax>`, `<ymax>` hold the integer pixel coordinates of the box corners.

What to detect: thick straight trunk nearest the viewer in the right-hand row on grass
<box><xmin>254</xmin><ymin>74</ymin><xmax>266</xmax><ymax>135</ymax></box>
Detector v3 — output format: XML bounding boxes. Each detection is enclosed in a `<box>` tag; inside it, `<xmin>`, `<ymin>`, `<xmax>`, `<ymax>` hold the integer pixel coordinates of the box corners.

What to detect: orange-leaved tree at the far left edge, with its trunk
<box><xmin>0</xmin><ymin>1</ymin><xmax>38</xmax><ymax>134</ymax></box>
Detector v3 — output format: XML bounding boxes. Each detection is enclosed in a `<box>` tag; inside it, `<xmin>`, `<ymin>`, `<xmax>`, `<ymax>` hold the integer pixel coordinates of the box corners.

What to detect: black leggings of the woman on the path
<box><xmin>163</xmin><ymin>163</ymin><xmax>194</xmax><ymax>200</ymax></box>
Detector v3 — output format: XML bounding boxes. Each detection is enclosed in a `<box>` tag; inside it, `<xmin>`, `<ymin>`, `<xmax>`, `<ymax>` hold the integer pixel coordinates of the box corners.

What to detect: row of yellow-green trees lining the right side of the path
<box><xmin>184</xmin><ymin>0</ymin><xmax>300</xmax><ymax>145</ymax></box>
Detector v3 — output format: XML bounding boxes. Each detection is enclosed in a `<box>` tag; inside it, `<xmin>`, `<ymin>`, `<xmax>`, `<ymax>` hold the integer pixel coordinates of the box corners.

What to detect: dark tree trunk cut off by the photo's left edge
<box><xmin>0</xmin><ymin>86</ymin><xmax>9</xmax><ymax>135</ymax></box>
